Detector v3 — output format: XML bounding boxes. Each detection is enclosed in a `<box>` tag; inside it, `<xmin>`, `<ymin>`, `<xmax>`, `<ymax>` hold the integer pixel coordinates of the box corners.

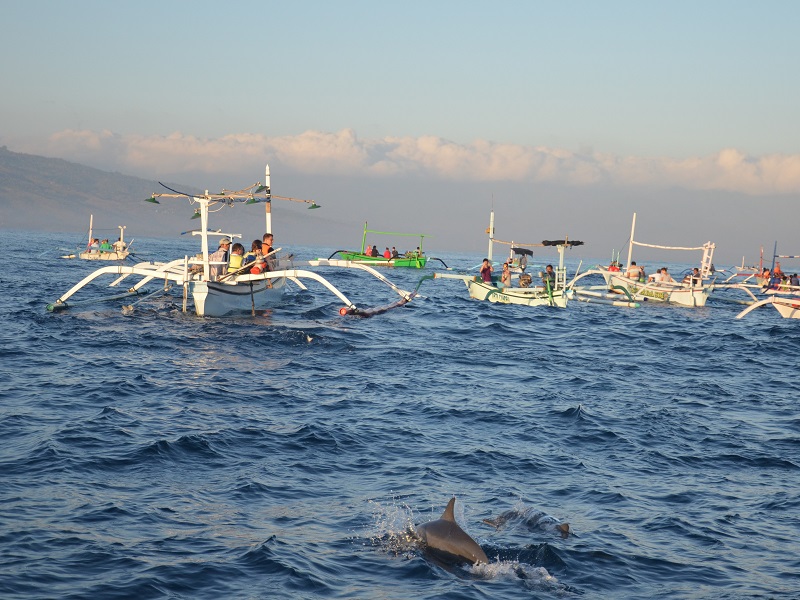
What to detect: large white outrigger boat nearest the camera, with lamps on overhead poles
<box><xmin>47</xmin><ymin>165</ymin><xmax>415</xmax><ymax>317</ymax></box>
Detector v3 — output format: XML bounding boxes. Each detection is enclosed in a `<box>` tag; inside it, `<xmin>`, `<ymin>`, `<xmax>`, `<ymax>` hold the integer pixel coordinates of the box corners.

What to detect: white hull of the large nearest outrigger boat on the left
<box><xmin>190</xmin><ymin>277</ymin><xmax>286</xmax><ymax>317</ymax></box>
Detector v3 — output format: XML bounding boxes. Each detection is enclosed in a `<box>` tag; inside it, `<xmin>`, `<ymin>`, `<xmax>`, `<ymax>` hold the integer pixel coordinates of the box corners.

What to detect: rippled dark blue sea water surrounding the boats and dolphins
<box><xmin>0</xmin><ymin>227</ymin><xmax>800</xmax><ymax>599</ymax></box>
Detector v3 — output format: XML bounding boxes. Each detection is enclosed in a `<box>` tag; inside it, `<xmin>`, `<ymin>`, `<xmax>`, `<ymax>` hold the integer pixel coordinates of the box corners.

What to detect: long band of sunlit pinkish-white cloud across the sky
<box><xmin>36</xmin><ymin>129</ymin><xmax>800</xmax><ymax>195</ymax></box>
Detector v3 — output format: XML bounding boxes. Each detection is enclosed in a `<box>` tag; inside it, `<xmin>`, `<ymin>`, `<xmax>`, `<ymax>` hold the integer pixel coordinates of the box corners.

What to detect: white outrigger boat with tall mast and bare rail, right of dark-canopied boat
<box><xmin>569</xmin><ymin>213</ymin><xmax>716</xmax><ymax>307</ymax></box>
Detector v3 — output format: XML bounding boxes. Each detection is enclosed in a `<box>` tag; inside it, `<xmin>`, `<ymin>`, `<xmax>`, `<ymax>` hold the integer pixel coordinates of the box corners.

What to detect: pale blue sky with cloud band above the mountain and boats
<box><xmin>0</xmin><ymin>0</ymin><xmax>800</xmax><ymax>257</ymax></box>
